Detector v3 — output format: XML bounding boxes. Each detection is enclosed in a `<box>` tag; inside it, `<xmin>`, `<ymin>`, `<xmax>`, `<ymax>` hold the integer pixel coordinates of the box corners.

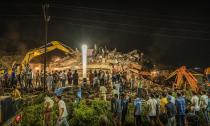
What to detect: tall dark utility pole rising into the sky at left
<box><xmin>42</xmin><ymin>0</ymin><xmax>50</xmax><ymax>92</ymax></box>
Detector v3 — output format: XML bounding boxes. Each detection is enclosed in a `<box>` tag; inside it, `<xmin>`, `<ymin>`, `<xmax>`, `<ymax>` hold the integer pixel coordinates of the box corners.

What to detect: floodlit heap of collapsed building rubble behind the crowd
<box><xmin>0</xmin><ymin>41</ymin><xmax>207</xmax><ymax>89</ymax></box>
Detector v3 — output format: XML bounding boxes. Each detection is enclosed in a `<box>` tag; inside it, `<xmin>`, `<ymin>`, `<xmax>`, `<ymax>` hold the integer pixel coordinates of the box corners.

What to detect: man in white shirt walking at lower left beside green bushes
<box><xmin>55</xmin><ymin>96</ymin><xmax>69</xmax><ymax>126</ymax></box>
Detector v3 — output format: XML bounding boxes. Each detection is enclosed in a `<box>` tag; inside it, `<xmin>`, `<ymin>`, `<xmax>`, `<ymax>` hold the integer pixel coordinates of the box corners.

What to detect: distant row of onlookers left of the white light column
<box><xmin>0</xmin><ymin>66</ymin><xmax>79</xmax><ymax>91</ymax></box>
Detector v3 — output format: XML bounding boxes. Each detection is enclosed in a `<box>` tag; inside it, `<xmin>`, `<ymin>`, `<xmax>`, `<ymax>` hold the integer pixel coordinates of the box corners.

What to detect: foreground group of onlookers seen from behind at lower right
<box><xmin>111</xmin><ymin>91</ymin><xmax>210</xmax><ymax>126</ymax></box>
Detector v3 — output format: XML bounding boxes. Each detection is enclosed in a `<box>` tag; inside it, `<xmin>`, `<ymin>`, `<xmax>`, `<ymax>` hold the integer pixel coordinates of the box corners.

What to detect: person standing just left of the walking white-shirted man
<box><xmin>44</xmin><ymin>96</ymin><xmax>54</xmax><ymax>126</ymax></box>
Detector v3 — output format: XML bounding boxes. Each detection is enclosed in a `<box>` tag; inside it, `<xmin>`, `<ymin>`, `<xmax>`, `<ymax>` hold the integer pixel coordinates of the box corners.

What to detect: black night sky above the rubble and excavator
<box><xmin>0</xmin><ymin>0</ymin><xmax>210</xmax><ymax>67</ymax></box>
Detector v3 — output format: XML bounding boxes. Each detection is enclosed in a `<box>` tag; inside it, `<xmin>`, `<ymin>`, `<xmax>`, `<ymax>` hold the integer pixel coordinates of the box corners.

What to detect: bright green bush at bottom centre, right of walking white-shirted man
<box><xmin>70</xmin><ymin>100</ymin><xmax>111</xmax><ymax>126</ymax></box>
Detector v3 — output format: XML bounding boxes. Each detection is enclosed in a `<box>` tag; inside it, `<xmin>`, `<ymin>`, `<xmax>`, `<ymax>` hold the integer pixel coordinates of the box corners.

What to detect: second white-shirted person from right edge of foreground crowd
<box><xmin>191</xmin><ymin>92</ymin><xmax>200</xmax><ymax>115</ymax></box>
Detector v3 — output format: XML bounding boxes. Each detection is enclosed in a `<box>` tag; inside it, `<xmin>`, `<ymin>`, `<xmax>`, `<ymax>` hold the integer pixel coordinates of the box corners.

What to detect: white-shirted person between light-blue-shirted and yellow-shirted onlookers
<box><xmin>147</xmin><ymin>95</ymin><xmax>157</xmax><ymax>125</ymax></box>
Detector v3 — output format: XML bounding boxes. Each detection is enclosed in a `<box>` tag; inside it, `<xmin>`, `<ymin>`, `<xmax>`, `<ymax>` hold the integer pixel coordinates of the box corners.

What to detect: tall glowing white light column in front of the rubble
<box><xmin>82</xmin><ymin>45</ymin><xmax>87</xmax><ymax>78</ymax></box>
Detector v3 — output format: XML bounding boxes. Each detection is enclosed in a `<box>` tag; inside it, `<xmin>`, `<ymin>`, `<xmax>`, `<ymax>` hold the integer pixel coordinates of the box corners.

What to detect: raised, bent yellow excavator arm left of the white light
<box><xmin>21</xmin><ymin>41</ymin><xmax>74</xmax><ymax>68</ymax></box>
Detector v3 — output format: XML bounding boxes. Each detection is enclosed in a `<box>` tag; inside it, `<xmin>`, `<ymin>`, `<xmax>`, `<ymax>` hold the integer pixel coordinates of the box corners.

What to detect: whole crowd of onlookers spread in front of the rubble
<box><xmin>1</xmin><ymin>62</ymin><xmax>210</xmax><ymax>126</ymax></box>
